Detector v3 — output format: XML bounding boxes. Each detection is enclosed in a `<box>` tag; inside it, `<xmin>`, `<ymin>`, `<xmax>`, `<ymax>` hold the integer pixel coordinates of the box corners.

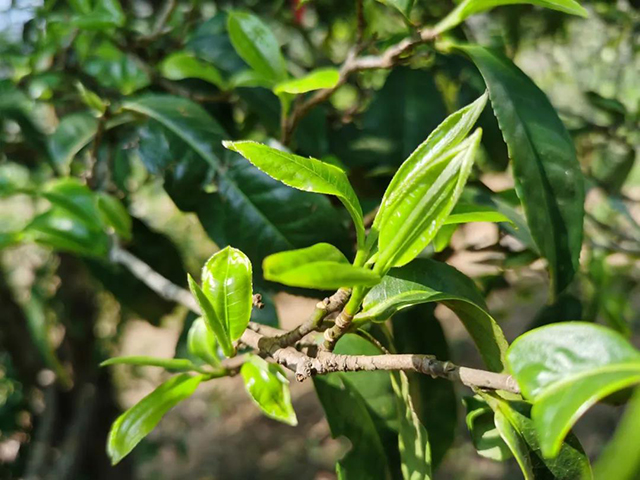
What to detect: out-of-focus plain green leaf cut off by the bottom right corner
<box><xmin>594</xmin><ymin>388</ymin><xmax>640</xmax><ymax>480</ymax></box>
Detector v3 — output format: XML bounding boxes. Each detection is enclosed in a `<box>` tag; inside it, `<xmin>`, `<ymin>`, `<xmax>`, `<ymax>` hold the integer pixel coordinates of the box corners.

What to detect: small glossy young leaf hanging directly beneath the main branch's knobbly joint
<box><xmin>240</xmin><ymin>355</ymin><xmax>298</xmax><ymax>426</ymax></box>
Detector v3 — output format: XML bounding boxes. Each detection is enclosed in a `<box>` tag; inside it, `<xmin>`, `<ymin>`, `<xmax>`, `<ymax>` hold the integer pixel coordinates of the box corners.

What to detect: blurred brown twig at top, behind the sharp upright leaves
<box><xmin>280</xmin><ymin>27</ymin><xmax>437</xmax><ymax>145</ymax></box>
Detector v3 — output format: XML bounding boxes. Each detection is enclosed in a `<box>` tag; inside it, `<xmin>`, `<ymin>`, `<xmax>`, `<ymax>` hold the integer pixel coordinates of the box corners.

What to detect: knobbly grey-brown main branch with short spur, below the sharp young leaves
<box><xmin>110</xmin><ymin>245</ymin><xmax>520</xmax><ymax>393</ymax></box>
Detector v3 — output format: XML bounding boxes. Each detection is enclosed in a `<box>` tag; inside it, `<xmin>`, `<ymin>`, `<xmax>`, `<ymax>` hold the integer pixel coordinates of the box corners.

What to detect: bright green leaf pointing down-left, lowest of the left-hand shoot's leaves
<box><xmin>107</xmin><ymin>373</ymin><xmax>204</xmax><ymax>465</ymax></box>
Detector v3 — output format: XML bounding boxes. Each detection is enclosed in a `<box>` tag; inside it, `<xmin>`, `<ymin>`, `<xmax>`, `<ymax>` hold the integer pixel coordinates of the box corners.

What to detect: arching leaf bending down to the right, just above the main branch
<box><xmin>355</xmin><ymin>259</ymin><xmax>508</xmax><ymax>372</ymax></box>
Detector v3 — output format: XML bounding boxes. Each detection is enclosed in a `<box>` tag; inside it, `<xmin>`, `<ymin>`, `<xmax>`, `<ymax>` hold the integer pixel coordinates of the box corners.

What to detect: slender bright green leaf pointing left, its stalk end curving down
<box><xmin>224</xmin><ymin>141</ymin><xmax>364</xmax><ymax>246</ymax></box>
